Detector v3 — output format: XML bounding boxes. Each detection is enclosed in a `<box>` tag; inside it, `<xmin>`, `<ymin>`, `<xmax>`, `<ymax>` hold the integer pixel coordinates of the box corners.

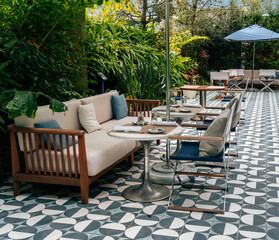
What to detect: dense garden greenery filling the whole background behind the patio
<box><xmin>0</xmin><ymin>0</ymin><xmax>279</xmax><ymax>186</ymax></box>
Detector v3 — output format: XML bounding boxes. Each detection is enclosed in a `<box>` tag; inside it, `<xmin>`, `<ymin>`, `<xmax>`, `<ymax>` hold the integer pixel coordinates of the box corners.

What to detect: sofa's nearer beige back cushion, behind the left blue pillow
<box><xmin>14</xmin><ymin>99</ymin><xmax>82</xmax><ymax>151</ymax></box>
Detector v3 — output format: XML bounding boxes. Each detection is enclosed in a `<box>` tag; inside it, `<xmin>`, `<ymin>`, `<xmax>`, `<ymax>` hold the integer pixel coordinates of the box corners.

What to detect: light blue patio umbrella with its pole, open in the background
<box><xmin>225</xmin><ymin>24</ymin><xmax>279</xmax><ymax>88</ymax></box>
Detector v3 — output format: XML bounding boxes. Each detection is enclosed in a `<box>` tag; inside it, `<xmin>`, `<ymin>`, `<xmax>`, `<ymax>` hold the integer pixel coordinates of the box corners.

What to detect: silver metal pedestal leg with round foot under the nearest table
<box><xmin>122</xmin><ymin>141</ymin><xmax>170</xmax><ymax>202</ymax></box>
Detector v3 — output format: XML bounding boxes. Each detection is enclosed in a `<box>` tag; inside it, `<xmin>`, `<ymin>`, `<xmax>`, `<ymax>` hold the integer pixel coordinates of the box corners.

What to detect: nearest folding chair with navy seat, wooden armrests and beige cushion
<box><xmin>168</xmin><ymin>102</ymin><xmax>236</xmax><ymax>214</ymax></box>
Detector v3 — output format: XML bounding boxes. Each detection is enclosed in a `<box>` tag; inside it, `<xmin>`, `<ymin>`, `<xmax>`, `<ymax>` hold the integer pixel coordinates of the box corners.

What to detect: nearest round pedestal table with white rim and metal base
<box><xmin>108</xmin><ymin>126</ymin><xmax>183</xmax><ymax>202</ymax></box>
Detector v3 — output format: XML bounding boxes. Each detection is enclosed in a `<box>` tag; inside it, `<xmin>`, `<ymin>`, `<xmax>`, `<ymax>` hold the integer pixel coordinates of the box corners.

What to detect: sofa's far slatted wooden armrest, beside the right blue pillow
<box><xmin>126</xmin><ymin>99</ymin><xmax>160</xmax><ymax>117</ymax></box>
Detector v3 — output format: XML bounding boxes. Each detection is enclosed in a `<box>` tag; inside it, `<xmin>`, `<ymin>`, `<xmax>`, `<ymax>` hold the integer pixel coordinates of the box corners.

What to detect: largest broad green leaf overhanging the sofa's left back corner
<box><xmin>6</xmin><ymin>91</ymin><xmax>39</xmax><ymax>119</ymax></box>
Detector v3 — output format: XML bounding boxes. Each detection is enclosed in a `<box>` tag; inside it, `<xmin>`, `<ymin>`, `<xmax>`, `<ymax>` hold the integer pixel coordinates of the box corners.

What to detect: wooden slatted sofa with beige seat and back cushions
<box><xmin>8</xmin><ymin>90</ymin><xmax>160</xmax><ymax>204</ymax></box>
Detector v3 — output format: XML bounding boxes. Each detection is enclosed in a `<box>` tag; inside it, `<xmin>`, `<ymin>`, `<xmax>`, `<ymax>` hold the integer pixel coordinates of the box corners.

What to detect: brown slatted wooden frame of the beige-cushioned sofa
<box><xmin>8</xmin><ymin>100</ymin><xmax>160</xmax><ymax>204</ymax></box>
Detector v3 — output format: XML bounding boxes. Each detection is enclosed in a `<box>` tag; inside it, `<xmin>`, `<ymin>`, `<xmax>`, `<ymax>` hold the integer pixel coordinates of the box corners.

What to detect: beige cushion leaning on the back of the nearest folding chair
<box><xmin>199</xmin><ymin>109</ymin><xmax>231</xmax><ymax>157</ymax></box>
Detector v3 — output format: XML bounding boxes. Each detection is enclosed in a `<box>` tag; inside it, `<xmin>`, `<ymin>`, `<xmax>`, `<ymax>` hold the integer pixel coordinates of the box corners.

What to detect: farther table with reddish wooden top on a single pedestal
<box><xmin>180</xmin><ymin>85</ymin><xmax>226</xmax><ymax>107</ymax></box>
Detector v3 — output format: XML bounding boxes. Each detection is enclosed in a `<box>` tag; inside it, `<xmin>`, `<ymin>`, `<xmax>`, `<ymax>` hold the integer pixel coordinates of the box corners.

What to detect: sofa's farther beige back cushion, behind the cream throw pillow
<box><xmin>81</xmin><ymin>90</ymin><xmax>119</xmax><ymax>124</ymax></box>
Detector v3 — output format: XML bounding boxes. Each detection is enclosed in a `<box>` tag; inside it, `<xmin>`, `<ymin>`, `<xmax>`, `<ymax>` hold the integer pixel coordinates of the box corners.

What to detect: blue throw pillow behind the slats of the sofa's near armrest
<box><xmin>34</xmin><ymin>120</ymin><xmax>77</xmax><ymax>151</ymax></box>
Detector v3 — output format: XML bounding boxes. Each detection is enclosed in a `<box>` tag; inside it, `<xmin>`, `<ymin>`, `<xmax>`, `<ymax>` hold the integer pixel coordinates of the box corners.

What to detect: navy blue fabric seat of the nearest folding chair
<box><xmin>170</xmin><ymin>141</ymin><xmax>224</xmax><ymax>162</ymax></box>
